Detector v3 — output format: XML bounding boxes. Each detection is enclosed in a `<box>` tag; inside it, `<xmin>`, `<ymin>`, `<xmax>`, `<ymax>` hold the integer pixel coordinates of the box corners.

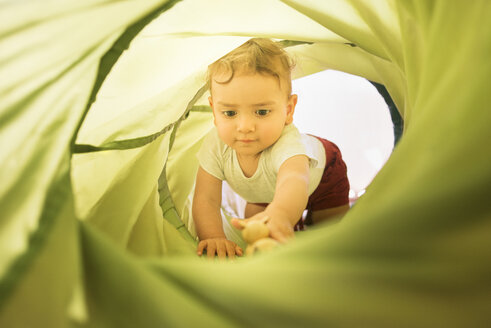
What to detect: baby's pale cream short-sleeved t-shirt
<box><xmin>197</xmin><ymin>124</ymin><xmax>326</xmax><ymax>203</ymax></box>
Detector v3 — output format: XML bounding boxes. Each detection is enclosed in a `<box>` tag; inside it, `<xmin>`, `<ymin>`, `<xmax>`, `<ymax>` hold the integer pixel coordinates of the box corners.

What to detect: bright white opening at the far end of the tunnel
<box><xmin>293</xmin><ymin>70</ymin><xmax>394</xmax><ymax>198</ymax></box>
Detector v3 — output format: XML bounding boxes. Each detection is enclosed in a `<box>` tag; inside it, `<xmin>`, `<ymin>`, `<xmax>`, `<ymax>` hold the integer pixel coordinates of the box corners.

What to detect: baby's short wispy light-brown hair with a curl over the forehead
<box><xmin>207</xmin><ymin>38</ymin><xmax>295</xmax><ymax>96</ymax></box>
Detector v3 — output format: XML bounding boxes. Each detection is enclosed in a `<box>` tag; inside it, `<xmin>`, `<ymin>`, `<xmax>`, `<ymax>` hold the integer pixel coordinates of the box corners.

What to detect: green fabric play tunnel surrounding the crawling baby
<box><xmin>0</xmin><ymin>0</ymin><xmax>491</xmax><ymax>327</ymax></box>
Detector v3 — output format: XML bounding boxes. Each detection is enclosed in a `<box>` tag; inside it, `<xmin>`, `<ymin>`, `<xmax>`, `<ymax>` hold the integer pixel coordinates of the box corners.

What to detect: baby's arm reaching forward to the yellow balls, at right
<box><xmin>264</xmin><ymin>155</ymin><xmax>309</xmax><ymax>241</ymax></box>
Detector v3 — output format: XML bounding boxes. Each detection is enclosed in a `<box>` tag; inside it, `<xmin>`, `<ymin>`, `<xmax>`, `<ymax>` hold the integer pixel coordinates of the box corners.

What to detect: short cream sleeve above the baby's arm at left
<box><xmin>196</xmin><ymin>129</ymin><xmax>225</xmax><ymax>180</ymax></box>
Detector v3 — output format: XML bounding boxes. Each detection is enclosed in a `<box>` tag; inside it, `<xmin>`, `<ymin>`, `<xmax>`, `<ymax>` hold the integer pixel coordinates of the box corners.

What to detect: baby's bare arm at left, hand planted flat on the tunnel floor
<box><xmin>193</xmin><ymin>167</ymin><xmax>242</xmax><ymax>258</ymax></box>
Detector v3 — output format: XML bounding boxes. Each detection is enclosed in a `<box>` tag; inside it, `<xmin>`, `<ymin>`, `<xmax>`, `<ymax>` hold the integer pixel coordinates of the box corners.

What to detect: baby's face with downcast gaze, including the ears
<box><xmin>209</xmin><ymin>73</ymin><xmax>296</xmax><ymax>157</ymax></box>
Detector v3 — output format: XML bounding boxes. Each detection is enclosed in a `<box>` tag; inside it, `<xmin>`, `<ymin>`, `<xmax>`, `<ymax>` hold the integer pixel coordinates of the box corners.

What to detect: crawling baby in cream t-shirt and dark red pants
<box><xmin>193</xmin><ymin>38</ymin><xmax>349</xmax><ymax>258</ymax></box>
